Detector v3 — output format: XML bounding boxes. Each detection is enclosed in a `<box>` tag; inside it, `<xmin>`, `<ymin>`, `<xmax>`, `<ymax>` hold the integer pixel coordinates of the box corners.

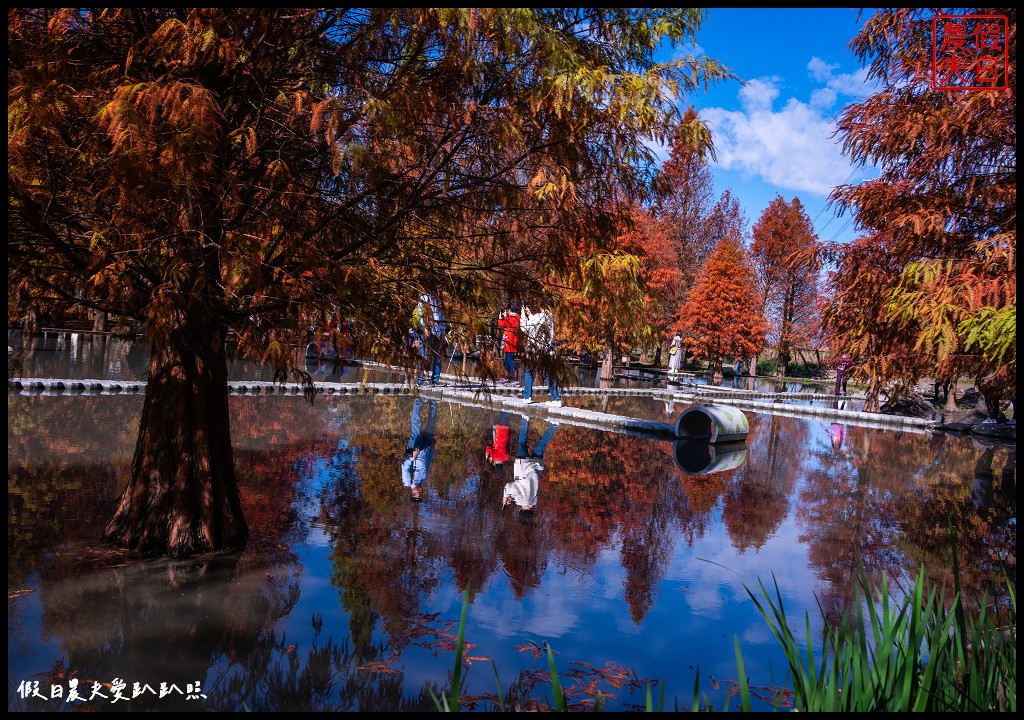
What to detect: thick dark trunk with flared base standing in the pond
<box><xmin>103</xmin><ymin>320</ymin><xmax>249</xmax><ymax>557</ymax></box>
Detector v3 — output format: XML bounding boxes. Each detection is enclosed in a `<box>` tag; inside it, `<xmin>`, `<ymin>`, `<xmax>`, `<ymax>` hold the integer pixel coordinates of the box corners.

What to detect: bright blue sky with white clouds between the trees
<box><xmin>663</xmin><ymin>7</ymin><xmax>878</xmax><ymax>243</ymax></box>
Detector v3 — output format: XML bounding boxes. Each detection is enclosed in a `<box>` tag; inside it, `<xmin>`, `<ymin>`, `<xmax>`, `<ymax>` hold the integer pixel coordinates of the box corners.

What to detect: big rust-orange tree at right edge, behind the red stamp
<box><xmin>823</xmin><ymin>8</ymin><xmax>1017</xmax><ymax>417</ymax></box>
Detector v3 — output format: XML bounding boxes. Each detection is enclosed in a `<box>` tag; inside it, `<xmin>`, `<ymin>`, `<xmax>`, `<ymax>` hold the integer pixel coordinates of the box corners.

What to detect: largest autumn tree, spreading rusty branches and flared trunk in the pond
<box><xmin>7</xmin><ymin>7</ymin><xmax>725</xmax><ymax>556</ymax></box>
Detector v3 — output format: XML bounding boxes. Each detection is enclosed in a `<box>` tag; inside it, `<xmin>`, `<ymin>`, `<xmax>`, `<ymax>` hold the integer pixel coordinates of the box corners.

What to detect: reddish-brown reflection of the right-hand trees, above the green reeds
<box><xmin>798</xmin><ymin>427</ymin><xmax>1016</xmax><ymax>626</ymax></box>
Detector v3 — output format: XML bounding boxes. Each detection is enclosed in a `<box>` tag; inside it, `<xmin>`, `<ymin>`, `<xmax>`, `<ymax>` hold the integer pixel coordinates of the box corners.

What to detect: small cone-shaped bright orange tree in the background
<box><xmin>681</xmin><ymin>235</ymin><xmax>767</xmax><ymax>375</ymax></box>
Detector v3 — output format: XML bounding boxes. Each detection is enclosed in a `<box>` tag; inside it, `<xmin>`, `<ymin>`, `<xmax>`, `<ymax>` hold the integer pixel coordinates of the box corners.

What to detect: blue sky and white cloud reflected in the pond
<box><xmin>8</xmin><ymin>344</ymin><xmax>1015</xmax><ymax>707</ymax></box>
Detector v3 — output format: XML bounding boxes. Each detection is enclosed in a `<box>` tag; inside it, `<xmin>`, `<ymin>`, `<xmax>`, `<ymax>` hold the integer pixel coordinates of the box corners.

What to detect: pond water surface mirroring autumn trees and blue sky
<box><xmin>7</xmin><ymin>339</ymin><xmax>1016</xmax><ymax>712</ymax></box>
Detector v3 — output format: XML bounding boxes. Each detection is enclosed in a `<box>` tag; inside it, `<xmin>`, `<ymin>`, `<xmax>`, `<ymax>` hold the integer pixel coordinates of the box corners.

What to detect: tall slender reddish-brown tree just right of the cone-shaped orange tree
<box><xmin>751</xmin><ymin>196</ymin><xmax>818</xmax><ymax>377</ymax></box>
